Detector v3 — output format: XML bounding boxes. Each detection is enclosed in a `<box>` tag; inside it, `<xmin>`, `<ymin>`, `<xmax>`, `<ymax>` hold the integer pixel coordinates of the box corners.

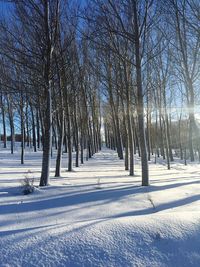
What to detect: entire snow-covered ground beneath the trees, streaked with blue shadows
<box><xmin>0</xmin><ymin>148</ymin><xmax>200</xmax><ymax>267</ymax></box>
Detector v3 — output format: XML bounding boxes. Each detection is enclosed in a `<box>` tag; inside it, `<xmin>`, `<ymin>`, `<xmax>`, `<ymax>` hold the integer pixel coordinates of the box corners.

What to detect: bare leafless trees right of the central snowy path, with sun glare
<box><xmin>90</xmin><ymin>0</ymin><xmax>200</xmax><ymax>185</ymax></box>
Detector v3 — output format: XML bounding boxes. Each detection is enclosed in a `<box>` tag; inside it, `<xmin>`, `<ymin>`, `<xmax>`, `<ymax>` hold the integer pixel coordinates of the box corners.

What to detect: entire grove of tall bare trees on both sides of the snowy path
<box><xmin>0</xmin><ymin>0</ymin><xmax>200</xmax><ymax>186</ymax></box>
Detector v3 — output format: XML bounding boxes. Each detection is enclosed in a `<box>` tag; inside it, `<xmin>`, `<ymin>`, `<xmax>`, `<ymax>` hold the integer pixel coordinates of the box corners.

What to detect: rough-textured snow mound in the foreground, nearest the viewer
<box><xmin>0</xmin><ymin>216</ymin><xmax>200</xmax><ymax>267</ymax></box>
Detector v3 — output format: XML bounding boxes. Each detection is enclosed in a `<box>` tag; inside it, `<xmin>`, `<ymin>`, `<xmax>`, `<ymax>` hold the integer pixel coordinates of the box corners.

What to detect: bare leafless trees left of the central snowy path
<box><xmin>0</xmin><ymin>0</ymin><xmax>101</xmax><ymax>186</ymax></box>
